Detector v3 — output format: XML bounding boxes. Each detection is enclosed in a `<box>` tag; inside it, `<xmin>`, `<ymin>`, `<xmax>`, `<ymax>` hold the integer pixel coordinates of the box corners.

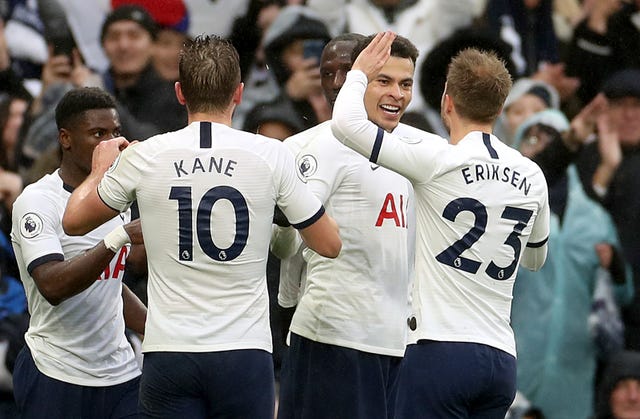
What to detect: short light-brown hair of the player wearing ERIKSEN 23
<box><xmin>446</xmin><ymin>48</ymin><xmax>512</xmax><ymax>123</ymax></box>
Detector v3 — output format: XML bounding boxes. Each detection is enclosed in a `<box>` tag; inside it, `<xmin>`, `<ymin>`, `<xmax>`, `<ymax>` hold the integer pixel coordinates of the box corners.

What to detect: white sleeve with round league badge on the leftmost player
<box><xmin>11</xmin><ymin>191</ymin><xmax>64</xmax><ymax>274</ymax></box>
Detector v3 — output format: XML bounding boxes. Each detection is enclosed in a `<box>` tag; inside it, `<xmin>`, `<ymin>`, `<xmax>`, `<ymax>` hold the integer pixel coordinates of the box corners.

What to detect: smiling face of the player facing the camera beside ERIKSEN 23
<box><xmin>364</xmin><ymin>56</ymin><xmax>415</xmax><ymax>132</ymax></box>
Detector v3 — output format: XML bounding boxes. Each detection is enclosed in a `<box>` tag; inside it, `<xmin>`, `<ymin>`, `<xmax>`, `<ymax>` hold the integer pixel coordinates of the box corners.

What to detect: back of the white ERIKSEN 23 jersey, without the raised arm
<box><xmin>413</xmin><ymin>132</ymin><xmax>548</xmax><ymax>355</ymax></box>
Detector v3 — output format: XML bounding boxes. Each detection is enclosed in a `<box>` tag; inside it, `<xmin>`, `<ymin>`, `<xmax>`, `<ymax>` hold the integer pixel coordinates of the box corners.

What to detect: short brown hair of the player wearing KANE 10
<box><xmin>179</xmin><ymin>35</ymin><xmax>240</xmax><ymax>113</ymax></box>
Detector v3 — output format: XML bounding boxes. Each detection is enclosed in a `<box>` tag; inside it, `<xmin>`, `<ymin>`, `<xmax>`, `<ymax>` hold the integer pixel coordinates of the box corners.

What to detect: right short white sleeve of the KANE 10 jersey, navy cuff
<box><xmin>276</xmin><ymin>145</ymin><xmax>324</xmax><ymax>229</ymax></box>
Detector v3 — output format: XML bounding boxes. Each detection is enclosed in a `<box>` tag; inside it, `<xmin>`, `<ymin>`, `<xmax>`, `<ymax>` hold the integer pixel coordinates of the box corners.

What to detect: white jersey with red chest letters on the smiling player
<box><xmin>281</xmin><ymin>121</ymin><xmax>439</xmax><ymax>356</ymax></box>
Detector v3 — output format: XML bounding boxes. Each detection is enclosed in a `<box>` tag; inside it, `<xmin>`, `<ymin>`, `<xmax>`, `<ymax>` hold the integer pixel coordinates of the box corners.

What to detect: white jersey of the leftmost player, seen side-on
<box><xmin>11</xmin><ymin>171</ymin><xmax>140</xmax><ymax>386</ymax></box>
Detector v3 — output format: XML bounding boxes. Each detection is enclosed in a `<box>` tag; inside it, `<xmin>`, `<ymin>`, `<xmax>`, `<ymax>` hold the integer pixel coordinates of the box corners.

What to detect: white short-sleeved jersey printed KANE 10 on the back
<box><xmin>98</xmin><ymin>122</ymin><xmax>324</xmax><ymax>352</ymax></box>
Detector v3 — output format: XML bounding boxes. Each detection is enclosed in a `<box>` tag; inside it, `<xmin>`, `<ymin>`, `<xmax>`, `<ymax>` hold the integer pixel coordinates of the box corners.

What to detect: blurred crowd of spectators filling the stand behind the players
<box><xmin>0</xmin><ymin>0</ymin><xmax>640</xmax><ymax>419</ymax></box>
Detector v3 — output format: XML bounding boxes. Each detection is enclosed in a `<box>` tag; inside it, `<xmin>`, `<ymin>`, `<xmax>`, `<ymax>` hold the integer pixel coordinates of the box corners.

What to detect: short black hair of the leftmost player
<box><xmin>56</xmin><ymin>87</ymin><xmax>116</xmax><ymax>129</ymax></box>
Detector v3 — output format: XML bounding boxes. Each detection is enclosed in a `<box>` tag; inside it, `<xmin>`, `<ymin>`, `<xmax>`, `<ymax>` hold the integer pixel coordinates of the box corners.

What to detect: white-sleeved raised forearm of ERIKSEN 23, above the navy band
<box><xmin>331</xmin><ymin>71</ymin><xmax>378</xmax><ymax>158</ymax></box>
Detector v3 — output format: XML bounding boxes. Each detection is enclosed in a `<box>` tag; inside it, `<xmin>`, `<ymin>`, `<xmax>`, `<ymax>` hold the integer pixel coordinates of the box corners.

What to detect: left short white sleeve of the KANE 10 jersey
<box><xmin>98</xmin><ymin>144</ymin><xmax>144</xmax><ymax>212</ymax></box>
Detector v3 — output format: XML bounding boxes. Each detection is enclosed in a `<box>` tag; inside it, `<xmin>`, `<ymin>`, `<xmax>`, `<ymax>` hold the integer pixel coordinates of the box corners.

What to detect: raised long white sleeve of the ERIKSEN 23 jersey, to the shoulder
<box><xmin>331</xmin><ymin>70</ymin><xmax>450</xmax><ymax>183</ymax></box>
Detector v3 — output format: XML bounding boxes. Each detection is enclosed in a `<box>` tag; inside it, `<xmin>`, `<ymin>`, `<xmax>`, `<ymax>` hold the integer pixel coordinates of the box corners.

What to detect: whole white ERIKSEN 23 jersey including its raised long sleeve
<box><xmin>333</xmin><ymin>71</ymin><xmax>549</xmax><ymax>356</ymax></box>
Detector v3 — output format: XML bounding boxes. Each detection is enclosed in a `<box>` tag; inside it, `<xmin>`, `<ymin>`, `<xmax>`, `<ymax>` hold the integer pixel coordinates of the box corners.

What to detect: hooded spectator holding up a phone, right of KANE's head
<box><xmin>236</xmin><ymin>6</ymin><xmax>331</xmax><ymax>135</ymax></box>
